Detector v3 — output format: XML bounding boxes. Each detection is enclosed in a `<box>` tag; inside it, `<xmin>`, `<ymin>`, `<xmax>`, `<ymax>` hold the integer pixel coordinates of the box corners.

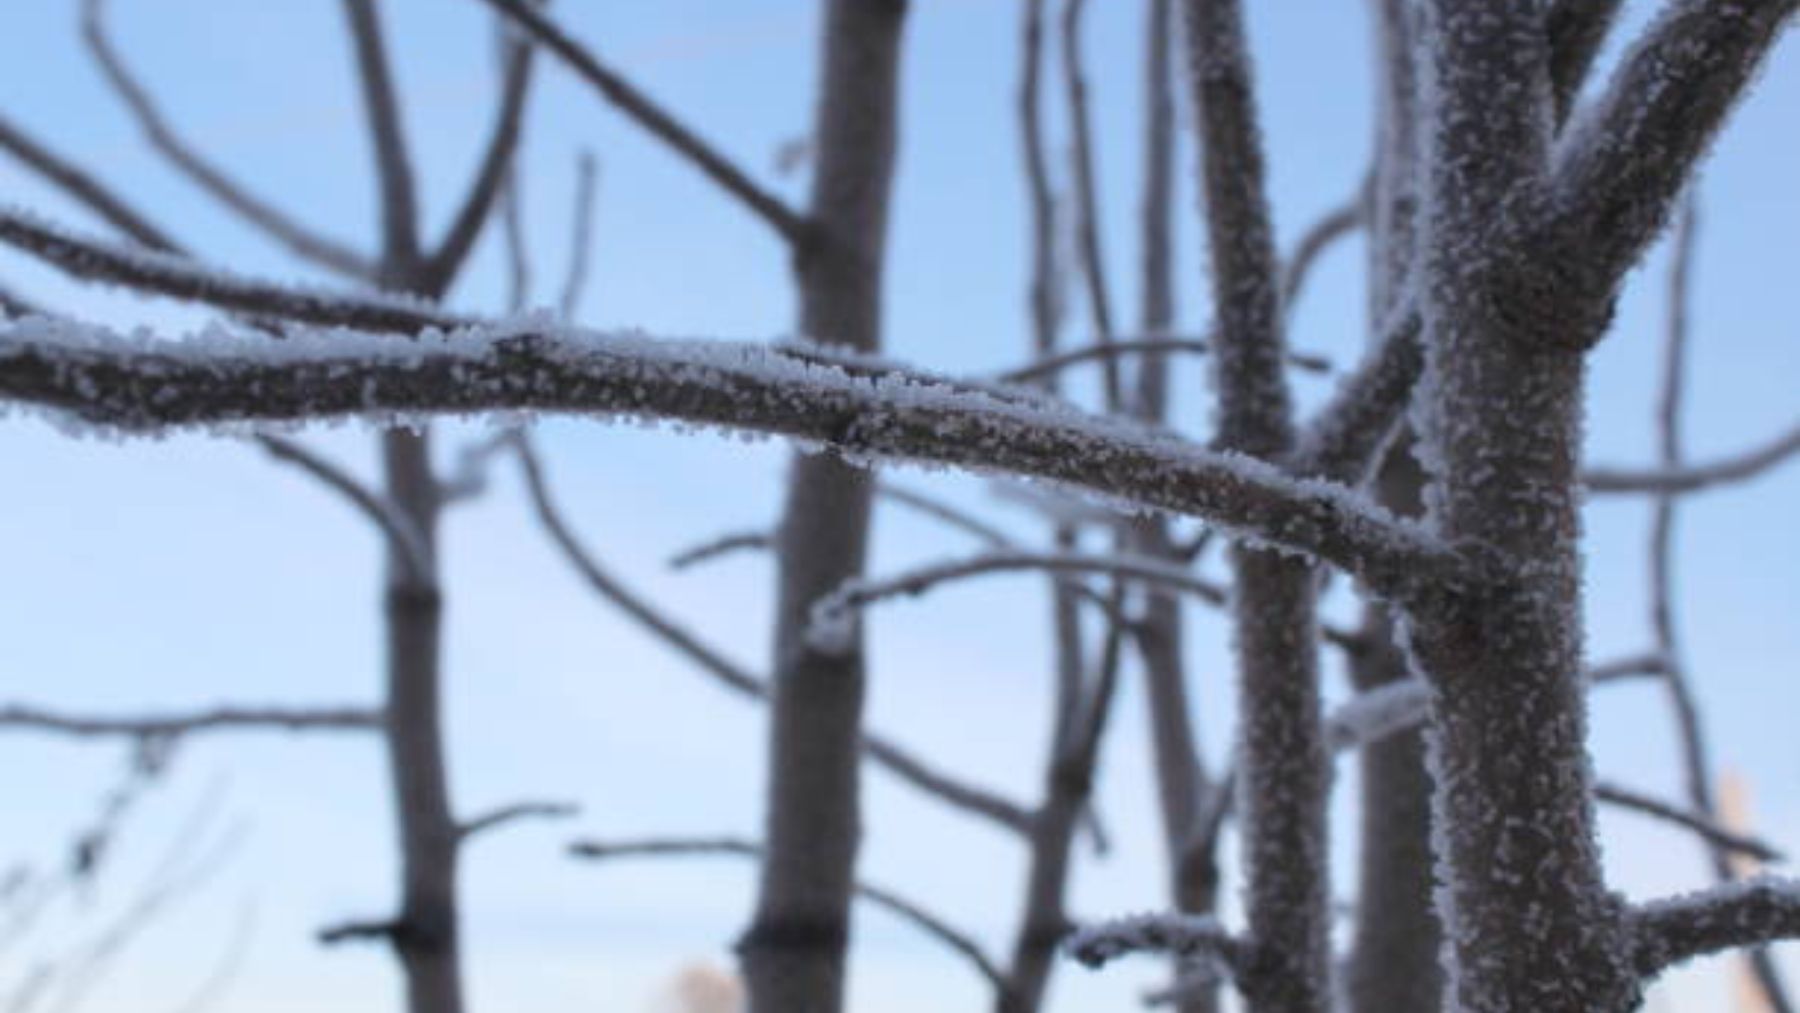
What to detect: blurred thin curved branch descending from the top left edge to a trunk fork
<box><xmin>81</xmin><ymin>0</ymin><xmax>374</xmax><ymax>279</ymax></box>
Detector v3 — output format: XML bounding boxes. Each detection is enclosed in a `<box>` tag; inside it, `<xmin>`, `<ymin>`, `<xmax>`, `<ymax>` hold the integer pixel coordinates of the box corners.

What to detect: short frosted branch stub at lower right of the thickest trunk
<box><xmin>1629</xmin><ymin>876</ymin><xmax>1800</xmax><ymax>975</ymax></box>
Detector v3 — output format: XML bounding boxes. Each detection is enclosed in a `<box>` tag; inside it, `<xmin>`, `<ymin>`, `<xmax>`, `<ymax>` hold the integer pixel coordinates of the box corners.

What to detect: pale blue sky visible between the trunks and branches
<box><xmin>0</xmin><ymin>0</ymin><xmax>1800</xmax><ymax>1013</ymax></box>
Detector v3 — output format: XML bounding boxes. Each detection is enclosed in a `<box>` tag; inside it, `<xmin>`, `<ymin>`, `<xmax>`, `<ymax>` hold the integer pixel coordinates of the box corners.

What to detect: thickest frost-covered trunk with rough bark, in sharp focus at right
<box><xmin>1409</xmin><ymin>0</ymin><xmax>1638</xmax><ymax>1013</ymax></box>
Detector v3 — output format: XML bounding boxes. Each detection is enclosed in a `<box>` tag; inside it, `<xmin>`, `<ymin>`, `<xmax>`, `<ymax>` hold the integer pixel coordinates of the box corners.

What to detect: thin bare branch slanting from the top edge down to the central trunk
<box><xmin>464</xmin><ymin>0</ymin><xmax>810</xmax><ymax>245</ymax></box>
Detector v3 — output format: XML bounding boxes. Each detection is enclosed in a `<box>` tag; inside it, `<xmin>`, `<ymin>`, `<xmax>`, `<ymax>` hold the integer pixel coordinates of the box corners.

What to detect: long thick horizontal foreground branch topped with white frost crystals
<box><xmin>0</xmin><ymin>317</ymin><xmax>1471</xmax><ymax>596</ymax></box>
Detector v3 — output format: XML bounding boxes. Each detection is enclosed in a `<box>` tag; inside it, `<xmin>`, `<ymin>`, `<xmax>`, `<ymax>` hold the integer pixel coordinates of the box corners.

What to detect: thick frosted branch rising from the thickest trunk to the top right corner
<box><xmin>1550</xmin><ymin>0</ymin><xmax>1800</xmax><ymax>293</ymax></box>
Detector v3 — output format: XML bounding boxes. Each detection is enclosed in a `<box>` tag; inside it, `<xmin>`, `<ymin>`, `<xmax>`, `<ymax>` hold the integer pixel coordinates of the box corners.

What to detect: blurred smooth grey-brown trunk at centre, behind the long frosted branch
<box><xmin>738</xmin><ymin>0</ymin><xmax>905</xmax><ymax>1013</ymax></box>
